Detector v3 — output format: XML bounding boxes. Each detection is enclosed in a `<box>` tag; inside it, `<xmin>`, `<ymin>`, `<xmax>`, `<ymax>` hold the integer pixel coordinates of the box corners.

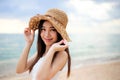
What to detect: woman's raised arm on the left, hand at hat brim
<box><xmin>16</xmin><ymin>28</ymin><xmax>36</xmax><ymax>73</ymax></box>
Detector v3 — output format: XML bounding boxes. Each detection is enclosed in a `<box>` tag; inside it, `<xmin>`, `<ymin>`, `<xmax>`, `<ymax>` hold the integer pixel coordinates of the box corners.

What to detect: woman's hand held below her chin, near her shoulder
<box><xmin>51</xmin><ymin>40</ymin><xmax>68</xmax><ymax>52</ymax></box>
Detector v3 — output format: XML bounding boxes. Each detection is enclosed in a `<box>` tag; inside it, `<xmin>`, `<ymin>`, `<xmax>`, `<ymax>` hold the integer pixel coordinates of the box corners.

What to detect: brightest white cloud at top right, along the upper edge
<box><xmin>68</xmin><ymin>0</ymin><xmax>114</xmax><ymax>20</ymax></box>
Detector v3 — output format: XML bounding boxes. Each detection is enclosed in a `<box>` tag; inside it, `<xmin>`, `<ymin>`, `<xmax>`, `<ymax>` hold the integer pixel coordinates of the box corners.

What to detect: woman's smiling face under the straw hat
<box><xmin>40</xmin><ymin>21</ymin><xmax>57</xmax><ymax>46</ymax></box>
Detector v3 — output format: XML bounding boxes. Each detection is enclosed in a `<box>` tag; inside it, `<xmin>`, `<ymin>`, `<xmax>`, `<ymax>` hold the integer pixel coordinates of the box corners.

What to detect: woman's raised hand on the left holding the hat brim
<box><xmin>24</xmin><ymin>28</ymin><xmax>35</xmax><ymax>44</ymax></box>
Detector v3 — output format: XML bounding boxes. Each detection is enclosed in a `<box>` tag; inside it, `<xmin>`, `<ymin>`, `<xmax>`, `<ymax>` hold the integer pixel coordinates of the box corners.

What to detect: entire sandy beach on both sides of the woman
<box><xmin>0</xmin><ymin>60</ymin><xmax>120</xmax><ymax>80</ymax></box>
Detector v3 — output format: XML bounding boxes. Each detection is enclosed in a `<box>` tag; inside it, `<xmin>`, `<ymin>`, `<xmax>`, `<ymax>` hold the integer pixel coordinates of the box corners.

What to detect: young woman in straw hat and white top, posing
<box><xmin>16</xmin><ymin>9</ymin><xmax>71</xmax><ymax>80</ymax></box>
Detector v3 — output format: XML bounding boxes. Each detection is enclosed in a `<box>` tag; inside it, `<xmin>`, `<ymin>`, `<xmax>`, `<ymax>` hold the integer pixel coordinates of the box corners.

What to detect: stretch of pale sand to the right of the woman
<box><xmin>60</xmin><ymin>61</ymin><xmax>120</xmax><ymax>80</ymax></box>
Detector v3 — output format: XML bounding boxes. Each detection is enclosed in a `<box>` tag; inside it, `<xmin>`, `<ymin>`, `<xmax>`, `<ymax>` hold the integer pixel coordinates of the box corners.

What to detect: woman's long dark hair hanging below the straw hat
<box><xmin>29</xmin><ymin>20</ymin><xmax>71</xmax><ymax>77</ymax></box>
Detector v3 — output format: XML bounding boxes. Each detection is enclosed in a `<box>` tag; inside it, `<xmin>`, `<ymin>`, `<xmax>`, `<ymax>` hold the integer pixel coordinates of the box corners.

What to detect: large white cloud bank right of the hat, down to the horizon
<box><xmin>66</xmin><ymin>0</ymin><xmax>120</xmax><ymax>35</ymax></box>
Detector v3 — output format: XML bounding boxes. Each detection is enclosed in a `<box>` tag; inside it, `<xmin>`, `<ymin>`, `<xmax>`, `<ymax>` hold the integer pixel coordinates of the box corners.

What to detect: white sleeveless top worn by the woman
<box><xmin>31</xmin><ymin>57</ymin><xmax>61</xmax><ymax>80</ymax></box>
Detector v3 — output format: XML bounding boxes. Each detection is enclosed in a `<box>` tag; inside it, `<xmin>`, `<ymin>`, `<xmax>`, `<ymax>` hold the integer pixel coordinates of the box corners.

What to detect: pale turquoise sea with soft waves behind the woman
<box><xmin>0</xmin><ymin>34</ymin><xmax>120</xmax><ymax>78</ymax></box>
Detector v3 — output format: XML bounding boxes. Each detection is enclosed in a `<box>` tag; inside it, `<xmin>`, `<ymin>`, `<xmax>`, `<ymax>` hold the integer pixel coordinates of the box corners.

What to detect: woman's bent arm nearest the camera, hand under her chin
<box><xmin>36</xmin><ymin>41</ymin><xmax>68</xmax><ymax>80</ymax></box>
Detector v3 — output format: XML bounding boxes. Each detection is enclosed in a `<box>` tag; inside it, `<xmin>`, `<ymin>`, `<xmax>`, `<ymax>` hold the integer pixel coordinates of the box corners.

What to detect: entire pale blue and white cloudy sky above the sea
<box><xmin>0</xmin><ymin>0</ymin><xmax>120</xmax><ymax>35</ymax></box>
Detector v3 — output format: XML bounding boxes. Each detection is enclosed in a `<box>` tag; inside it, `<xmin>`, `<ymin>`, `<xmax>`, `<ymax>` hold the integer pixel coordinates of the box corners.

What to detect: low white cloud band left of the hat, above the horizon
<box><xmin>0</xmin><ymin>19</ymin><xmax>27</xmax><ymax>33</ymax></box>
